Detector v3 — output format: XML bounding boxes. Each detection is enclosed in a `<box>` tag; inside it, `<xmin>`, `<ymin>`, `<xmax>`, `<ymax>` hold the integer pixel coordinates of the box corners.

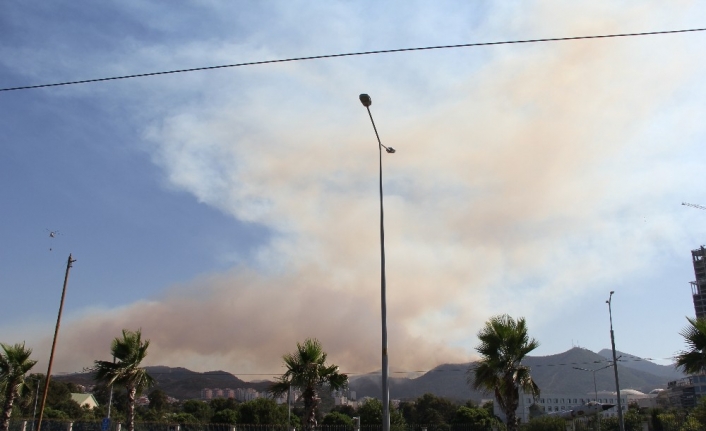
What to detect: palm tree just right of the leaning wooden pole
<box><xmin>93</xmin><ymin>329</ymin><xmax>155</xmax><ymax>431</ymax></box>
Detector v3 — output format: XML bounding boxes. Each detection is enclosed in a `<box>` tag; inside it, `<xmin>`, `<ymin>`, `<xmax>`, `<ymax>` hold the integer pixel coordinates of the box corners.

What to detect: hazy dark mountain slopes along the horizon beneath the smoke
<box><xmin>55</xmin><ymin>347</ymin><xmax>683</xmax><ymax>401</ymax></box>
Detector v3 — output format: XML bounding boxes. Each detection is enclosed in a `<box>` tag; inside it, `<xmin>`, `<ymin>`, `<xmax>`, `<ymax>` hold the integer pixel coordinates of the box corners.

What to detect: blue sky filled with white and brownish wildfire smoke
<box><xmin>0</xmin><ymin>0</ymin><xmax>706</xmax><ymax>380</ymax></box>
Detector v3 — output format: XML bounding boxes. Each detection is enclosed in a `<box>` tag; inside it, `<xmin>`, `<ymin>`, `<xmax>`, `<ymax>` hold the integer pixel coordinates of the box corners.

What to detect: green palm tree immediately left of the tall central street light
<box><xmin>269</xmin><ymin>338</ymin><xmax>348</xmax><ymax>429</ymax></box>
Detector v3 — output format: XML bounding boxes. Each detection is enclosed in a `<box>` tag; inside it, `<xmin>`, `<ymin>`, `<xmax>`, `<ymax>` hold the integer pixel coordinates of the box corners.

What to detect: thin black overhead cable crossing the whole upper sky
<box><xmin>0</xmin><ymin>28</ymin><xmax>706</xmax><ymax>91</ymax></box>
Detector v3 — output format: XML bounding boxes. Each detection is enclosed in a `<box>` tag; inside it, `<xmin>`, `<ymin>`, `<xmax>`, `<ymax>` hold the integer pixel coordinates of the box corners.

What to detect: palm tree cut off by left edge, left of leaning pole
<box><xmin>0</xmin><ymin>343</ymin><xmax>37</xmax><ymax>431</ymax></box>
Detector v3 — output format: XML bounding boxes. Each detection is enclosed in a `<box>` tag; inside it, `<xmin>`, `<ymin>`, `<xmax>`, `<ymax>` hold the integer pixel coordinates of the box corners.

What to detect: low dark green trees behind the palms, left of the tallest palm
<box><xmin>12</xmin><ymin>384</ymin><xmax>500</xmax><ymax>431</ymax></box>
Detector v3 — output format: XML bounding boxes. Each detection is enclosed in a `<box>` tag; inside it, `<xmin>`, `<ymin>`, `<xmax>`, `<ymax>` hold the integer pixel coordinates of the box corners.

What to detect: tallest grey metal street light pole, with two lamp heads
<box><xmin>359</xmin><ymin>94</ymin><xmax>395</xmax><ymax>431</ymax></box>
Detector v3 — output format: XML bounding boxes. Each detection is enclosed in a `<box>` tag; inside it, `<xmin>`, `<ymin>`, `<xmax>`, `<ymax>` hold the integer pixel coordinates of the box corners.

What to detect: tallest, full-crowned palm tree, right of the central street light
<box><xmin>468</xmin><ymin>314</ymin><xmax>539</xmax><ymax>431</ymax></box>
